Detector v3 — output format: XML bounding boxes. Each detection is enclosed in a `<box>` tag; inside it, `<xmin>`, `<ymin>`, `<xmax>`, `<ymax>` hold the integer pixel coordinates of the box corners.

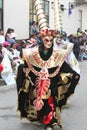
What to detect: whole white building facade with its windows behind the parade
<box><xmin>0</xmin><ymin>0</ymin><xmax>87</xmax><ymax>39</ymax></box>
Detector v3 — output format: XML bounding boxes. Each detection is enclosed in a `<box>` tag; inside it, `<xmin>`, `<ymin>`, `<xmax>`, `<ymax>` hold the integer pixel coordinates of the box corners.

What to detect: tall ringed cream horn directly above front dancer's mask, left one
<box><xmin>34</xmin><ymin>0</ymin><xmax>49</xmax><ymax>30</ymax></box>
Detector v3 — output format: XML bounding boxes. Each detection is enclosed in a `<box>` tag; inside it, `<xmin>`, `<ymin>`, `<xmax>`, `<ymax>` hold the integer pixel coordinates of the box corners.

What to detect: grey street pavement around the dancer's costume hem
<box><xmin>0</xmin><ymin>60</ymin><xmax>87</xmax><ymax>130</ymax></box>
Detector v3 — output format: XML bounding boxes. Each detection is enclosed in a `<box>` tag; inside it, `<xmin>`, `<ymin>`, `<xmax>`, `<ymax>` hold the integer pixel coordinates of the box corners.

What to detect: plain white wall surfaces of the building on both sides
<box><xmin>3</xmin><ymin>0</ymin><xmax>87</xmax><ymax>39</ymax></box>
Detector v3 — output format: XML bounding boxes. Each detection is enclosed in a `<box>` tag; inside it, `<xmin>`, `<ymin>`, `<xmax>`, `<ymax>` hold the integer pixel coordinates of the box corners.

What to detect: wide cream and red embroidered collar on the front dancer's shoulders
<box><xmin>24</xmin><ymin>49</ymin><xmax>67</xmax><ymax>78</ymax></box>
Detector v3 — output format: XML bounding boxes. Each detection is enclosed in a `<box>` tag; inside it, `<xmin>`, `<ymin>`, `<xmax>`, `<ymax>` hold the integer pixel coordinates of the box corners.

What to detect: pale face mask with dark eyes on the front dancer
<box><xmin>42</xmin><ymin>36</ymin><xmax>53</xmax><ymax>49</ymax></box>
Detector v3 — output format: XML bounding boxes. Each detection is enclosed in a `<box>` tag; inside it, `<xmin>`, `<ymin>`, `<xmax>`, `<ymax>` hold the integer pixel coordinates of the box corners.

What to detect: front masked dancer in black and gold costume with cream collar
<box><xmin>16</xmin><ymin>0</ymin><xmax>79</xmax><ymax>130</ymax></box>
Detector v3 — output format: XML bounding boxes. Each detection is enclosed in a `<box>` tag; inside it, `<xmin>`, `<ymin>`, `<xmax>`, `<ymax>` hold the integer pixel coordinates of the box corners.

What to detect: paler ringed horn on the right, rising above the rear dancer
<box><xmin>54</xmin><ymin>0</ymin><xmax>63</xmax><ymax>30</ymax></box>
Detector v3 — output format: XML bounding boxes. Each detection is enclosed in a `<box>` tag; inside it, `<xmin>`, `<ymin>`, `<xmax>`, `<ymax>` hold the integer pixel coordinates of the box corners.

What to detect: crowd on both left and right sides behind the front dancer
<box><xmin>0</xmin><ymin>26</ymin><xmax>87</xmax><ymax>84</ymax></box>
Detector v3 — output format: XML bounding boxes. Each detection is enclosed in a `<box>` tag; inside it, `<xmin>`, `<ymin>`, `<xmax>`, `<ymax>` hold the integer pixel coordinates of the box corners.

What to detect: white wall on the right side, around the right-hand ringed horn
<box><xmin>49</xmin><ymin>0</ymin><xmax>87</xmax><ymax>35</ymax></box>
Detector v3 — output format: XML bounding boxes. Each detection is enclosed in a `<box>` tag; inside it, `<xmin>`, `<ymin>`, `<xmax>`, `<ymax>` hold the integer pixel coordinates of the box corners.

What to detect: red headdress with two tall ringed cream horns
<box><xmin>34</xmin><ymin>0</ymin><xmax>62</xmax><ymax>38</ymax></box>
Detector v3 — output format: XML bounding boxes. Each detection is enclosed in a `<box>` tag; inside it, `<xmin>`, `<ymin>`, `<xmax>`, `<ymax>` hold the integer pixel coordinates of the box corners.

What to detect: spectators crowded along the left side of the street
<box><xmin>0</xmin><ymin>25</ymin><xmax>40</xmax><ymax>86</ymax></box>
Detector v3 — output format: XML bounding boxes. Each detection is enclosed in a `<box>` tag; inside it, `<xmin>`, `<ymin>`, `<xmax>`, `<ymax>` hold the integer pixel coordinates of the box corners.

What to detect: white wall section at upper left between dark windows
<box><xmin>4</xmin><ymin>0</ymin><xmax>29</xmax><ymax>39</ymax></box>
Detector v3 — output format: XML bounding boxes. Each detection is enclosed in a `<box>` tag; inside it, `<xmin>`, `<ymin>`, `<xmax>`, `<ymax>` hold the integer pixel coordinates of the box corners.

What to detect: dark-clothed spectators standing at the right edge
<box><xmin>68</xmin><ymin>28</ymin><xmax>87</xmax><ymax>61</ymax></box>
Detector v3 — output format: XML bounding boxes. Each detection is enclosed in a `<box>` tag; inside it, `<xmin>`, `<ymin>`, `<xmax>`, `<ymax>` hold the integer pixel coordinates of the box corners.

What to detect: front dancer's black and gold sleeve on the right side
<box><xmin>58</xmin><ymin>62</ymin><xmax>80</xmax><ymax>109</ymax></box>
